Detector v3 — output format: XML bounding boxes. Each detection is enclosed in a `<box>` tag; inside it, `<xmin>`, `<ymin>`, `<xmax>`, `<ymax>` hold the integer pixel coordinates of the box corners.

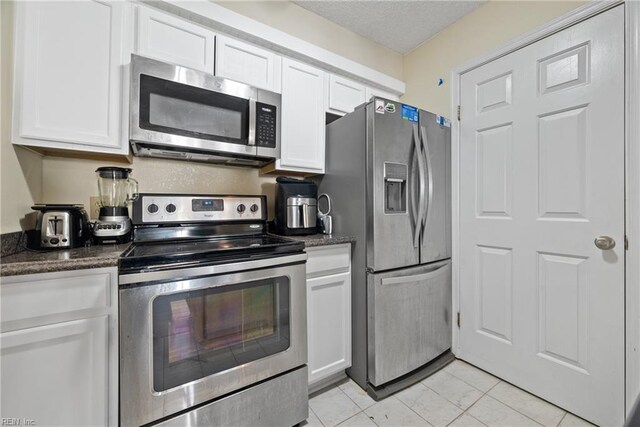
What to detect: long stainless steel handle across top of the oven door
<box><xmin>118</xmin><ymin>253</ymin><xmax>307</xmax><ymax>285</ymax></box>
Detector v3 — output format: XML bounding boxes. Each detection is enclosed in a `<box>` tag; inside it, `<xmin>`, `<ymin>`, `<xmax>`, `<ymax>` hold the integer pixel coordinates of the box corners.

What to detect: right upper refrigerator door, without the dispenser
<box><xmin>420</xmin><ymin>111</ymin><xmax>451</xmax><ymax>264</ymax></box>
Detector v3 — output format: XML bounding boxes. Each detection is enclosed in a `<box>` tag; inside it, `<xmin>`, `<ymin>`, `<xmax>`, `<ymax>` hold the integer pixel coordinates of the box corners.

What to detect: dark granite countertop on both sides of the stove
<box><xmin>0</xmin><ymin>234</ymin><xmax>355</xmax><ymax>276</ymax></box>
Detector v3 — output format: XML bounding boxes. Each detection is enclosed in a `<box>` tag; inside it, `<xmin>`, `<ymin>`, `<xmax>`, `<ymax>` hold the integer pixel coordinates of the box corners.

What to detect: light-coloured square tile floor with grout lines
<box><xmin>302</xmin><ymin>360</ymin><xmax>592</xmax><ymax>427</ymax></box>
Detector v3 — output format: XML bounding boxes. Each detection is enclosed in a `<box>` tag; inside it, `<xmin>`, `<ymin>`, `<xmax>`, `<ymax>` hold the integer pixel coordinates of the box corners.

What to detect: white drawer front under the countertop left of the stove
<box><xmin>0</xmin><ymin>271</ymin><xmax>113</xmax><ymax>330</ymax></box>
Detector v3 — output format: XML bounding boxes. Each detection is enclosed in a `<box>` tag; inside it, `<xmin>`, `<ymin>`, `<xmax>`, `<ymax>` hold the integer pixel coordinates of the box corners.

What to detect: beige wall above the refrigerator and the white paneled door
<box><xmin>402</xmin><ymin>1</ymin><xmax>585</xmax><ymax>117</ymax></box>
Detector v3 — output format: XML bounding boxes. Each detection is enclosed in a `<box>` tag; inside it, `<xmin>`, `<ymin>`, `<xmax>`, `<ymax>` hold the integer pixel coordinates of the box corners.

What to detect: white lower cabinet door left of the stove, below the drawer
<box><xmin>0</xmin><ymin>316</ymin><xmax>109</xmax><ymax>426</ymax></box>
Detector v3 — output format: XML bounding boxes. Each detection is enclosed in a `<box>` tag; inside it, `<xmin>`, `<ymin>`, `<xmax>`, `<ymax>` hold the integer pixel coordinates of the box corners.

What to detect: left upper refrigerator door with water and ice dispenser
<box><xmin>367</xmin><ymin>100</ymin><xmax>420</xmax><ymax>271</ymax></box>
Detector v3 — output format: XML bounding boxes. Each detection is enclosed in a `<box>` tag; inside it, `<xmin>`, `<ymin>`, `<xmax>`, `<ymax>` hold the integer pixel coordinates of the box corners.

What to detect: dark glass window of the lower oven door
<box><xmin>153</xmin><ymin>276</ymin><xmax>290</xmax><ymax>392</ymax></box>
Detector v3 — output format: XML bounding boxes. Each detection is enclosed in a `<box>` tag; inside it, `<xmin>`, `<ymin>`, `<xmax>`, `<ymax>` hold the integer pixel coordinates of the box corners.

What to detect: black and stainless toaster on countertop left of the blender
<box><xmin>27</xmin><ymin>204</ymin><xmax>91</xmax><ymax>250</ymax></box>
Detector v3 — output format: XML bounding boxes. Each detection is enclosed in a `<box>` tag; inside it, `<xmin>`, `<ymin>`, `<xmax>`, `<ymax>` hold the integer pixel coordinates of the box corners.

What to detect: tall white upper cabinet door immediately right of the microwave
<box><xmin>276</xmin><ymin>58</ymin><xmax>325</xmax><ymax>173</ymax></box>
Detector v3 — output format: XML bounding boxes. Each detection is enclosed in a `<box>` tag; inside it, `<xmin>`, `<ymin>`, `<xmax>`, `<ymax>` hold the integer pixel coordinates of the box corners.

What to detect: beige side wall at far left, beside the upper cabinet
<box><xmin>0</xmin><ymin>1</ymin><xmax>42</xmax><ymax>234</ymax></box>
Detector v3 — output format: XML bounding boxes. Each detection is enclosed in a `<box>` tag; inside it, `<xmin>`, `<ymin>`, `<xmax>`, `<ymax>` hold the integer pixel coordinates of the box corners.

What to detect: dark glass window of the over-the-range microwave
<box><xmin>139</xmin><ymin>74</ymin><xmax>249</xmax><ymax>145</ymax></box>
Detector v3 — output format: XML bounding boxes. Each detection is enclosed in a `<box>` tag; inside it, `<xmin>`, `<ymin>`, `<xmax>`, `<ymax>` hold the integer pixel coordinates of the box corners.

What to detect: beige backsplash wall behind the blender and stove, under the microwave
<box><xmin>40</xmin><ymin>157</ymin><xmax>275</xmax><ymax>218</ymax></box>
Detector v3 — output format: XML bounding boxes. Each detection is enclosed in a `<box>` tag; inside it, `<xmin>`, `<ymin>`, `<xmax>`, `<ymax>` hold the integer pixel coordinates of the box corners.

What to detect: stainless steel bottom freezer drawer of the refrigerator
<box><xmin>367</xmin><ymin>261</ymin><xmax>451</xmax><ymax>386</ymax></box>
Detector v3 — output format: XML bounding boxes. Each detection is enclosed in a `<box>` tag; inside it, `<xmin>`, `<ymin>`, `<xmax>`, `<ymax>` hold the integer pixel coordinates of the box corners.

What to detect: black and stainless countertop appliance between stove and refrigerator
<box><xmin>275</xmin><ymin>177</ymin><xmax>318</xmax><ymax>236</ymax></box>
